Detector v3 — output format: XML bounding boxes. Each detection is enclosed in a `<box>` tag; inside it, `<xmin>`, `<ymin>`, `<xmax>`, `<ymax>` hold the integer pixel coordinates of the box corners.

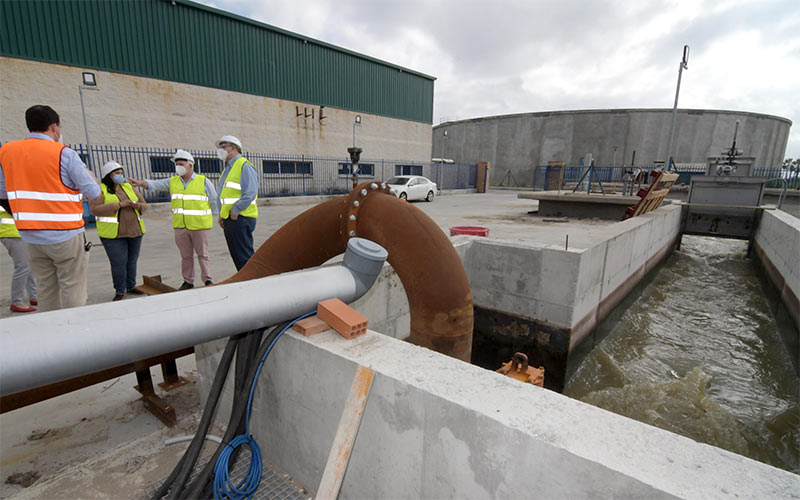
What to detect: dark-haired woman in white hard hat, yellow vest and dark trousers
<box><xmin>95</xmin><ymin>161</ymin><xmax>147</xmax><ymax>300</ymax></box>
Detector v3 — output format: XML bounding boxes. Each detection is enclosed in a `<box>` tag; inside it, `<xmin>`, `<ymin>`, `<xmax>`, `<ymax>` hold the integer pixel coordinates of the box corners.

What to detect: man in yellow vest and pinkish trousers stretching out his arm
<box><xmin>130</xmin><ymin>149</ymin><xmax>219</xmax><ymax>290</ymax></box>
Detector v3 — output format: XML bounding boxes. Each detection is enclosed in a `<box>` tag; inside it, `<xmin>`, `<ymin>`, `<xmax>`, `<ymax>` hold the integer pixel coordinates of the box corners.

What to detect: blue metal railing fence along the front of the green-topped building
<box><xmin>70</xmin><ymin>144</ymin><xmax>478</xmax><ymax>201</ymax></box>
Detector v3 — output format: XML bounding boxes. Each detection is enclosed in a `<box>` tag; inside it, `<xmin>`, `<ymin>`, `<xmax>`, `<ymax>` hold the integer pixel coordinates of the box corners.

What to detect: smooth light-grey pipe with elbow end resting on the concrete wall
<box><xmin>0</xmin><ymin>238</ymin><xmax>387</xmax><ymax>396</ymax></box>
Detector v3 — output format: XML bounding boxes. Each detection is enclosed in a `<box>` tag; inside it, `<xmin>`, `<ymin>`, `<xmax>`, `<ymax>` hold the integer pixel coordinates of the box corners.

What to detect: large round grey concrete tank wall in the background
<box><xmin>432</xmin><ymin>109</ymin><xmax>792</xmax><ymax>186</ymax></box>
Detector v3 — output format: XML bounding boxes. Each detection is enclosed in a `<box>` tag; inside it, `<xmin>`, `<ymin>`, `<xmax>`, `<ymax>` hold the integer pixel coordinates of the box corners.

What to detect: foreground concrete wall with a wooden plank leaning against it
<box><xmin>198</xmin><ymin>331</ymin><xmax>797</xmax><ymax>499</ymax></box>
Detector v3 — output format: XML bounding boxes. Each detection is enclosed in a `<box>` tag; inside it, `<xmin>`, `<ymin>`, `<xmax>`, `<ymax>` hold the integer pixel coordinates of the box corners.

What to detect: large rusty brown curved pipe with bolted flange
<box><xmin>224</xmin><ymin>182</ymin><xmax>473</xmax><ymax>362</ymax></box>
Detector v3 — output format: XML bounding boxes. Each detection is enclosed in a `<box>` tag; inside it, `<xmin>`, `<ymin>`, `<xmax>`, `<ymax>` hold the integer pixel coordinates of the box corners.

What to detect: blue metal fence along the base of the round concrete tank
<box><xmin>533</xmin><ymin>165</ymin><xmax>800</xmax><ymax>191</ymax></box>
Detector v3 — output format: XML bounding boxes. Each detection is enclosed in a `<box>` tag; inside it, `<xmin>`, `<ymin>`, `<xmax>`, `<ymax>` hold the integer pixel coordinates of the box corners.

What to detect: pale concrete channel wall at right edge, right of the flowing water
<box><xmin>755</xmin><ymin>210</ymin><xmax>800</xmax><ymax>297</ymax></box>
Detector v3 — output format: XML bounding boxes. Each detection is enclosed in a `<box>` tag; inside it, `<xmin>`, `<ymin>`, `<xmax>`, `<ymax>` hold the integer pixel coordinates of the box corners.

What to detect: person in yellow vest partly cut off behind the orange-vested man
<box><xmin>0</xmin><ymin>207</ymin><xmax>39</xmax><ymax>312</ymax></box>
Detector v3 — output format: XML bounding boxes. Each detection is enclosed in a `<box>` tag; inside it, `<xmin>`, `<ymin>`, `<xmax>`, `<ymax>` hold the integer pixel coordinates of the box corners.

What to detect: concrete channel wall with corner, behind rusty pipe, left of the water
<box><xmin>462</xmin><ymin>205</ymin><xmax>681</xmax><ymax>340</ymax></box>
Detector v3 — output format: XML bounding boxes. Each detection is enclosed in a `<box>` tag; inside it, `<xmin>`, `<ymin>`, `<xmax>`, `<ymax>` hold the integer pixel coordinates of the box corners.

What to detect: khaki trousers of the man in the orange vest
<box><xmin>25</xmin><ymin>233</ymin><xmax>89</xmax><ymax>311</ymax></box>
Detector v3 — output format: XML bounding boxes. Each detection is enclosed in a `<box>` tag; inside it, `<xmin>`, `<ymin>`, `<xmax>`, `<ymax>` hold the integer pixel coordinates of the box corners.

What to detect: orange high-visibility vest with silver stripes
<box><xmin>0</xmin><ymin>137</ymin><xmax>83</xmax><ymax>230</ymax></box>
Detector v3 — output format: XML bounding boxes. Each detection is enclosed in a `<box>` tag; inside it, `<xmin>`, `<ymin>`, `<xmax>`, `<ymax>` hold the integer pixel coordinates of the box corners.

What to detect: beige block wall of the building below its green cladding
<box><xmin>0</xmin><ymin>57</ymin><xmax>431</xmax><ymax>161</ymax></box>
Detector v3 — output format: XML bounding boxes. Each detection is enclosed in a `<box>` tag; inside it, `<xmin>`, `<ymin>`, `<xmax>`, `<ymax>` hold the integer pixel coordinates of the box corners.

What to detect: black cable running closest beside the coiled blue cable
<box><xmin>179</xmin><ymin>321</ymin><xmax>291</xmax><ymax>499</ymax></box>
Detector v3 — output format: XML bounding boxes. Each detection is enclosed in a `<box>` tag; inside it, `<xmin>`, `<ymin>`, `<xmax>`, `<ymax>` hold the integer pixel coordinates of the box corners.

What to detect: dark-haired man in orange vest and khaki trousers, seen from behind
<box><xmin>0</xmin><ymin>105</ymin><xmax>103</xmax><ymax>311</ymax></box>
